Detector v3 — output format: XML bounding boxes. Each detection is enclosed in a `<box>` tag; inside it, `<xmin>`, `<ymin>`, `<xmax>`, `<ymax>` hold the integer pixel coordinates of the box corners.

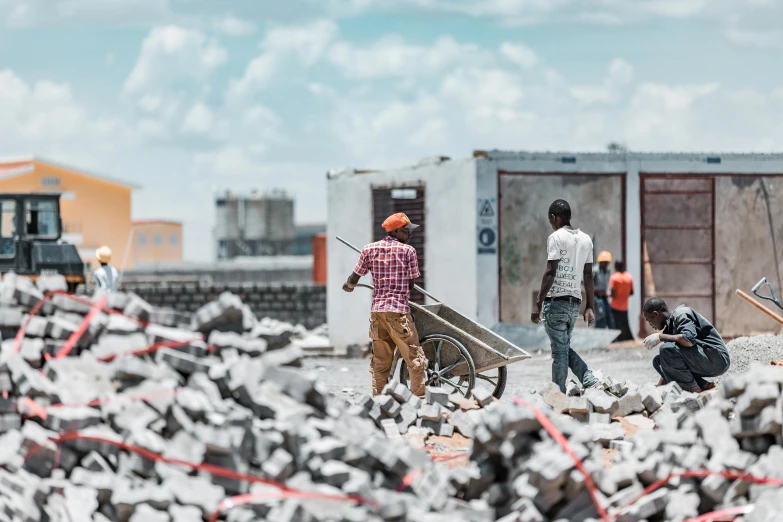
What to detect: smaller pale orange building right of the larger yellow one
<box><xmin>130</xmin><ymin>219</ymin><xmax>182</xmax><ymax>265</ymax></box>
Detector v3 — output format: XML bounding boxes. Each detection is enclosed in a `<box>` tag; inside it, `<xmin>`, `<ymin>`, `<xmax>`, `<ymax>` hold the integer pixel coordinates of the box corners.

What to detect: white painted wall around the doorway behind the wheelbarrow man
<box><xmin>326</xmin><ymin>158</ymin><xmax>478</xmax><ymax>347</ymax></box>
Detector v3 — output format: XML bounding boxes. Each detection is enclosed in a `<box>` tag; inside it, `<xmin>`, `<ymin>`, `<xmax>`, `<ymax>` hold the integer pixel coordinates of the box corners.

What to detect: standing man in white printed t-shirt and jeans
<box><xmin>530</xmin><ymin>199</ymin><xmax>598</xmax><ymax>393</ymax></box>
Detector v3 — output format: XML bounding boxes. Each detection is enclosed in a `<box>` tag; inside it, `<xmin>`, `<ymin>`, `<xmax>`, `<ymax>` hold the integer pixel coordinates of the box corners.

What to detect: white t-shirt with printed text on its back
<box><xmin>546</xmin><ymin>227</ymin><xmax>593</xmax><ymax>299</ymax></box>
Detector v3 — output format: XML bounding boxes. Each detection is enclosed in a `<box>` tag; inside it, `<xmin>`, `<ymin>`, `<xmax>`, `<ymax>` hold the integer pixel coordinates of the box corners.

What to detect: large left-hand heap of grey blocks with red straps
<box><xmin>0</xmin><ymin>276</ymin><xmax>494</xmax><ymax>522</ymax></box>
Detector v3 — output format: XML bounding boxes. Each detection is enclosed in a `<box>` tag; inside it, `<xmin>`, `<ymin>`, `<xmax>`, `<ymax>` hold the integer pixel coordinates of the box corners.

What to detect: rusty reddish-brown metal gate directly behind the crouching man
<box><xmin>640</xmin><ymin>174</ymin><xmax>717</xmax><ymax>334</ymax></box>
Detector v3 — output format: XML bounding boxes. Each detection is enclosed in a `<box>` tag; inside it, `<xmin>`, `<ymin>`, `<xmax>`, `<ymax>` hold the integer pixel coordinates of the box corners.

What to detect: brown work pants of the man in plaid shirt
<box><xmin>370</xmin><ymin>312</ymin><xmax>427</xmax><ymax>398</ymax></box>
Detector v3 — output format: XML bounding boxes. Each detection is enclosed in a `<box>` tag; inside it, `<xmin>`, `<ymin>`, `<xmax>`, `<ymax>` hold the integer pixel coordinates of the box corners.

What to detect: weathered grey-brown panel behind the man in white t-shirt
<box><xmin>499</xmin><ymin>174</ymin><xmax>624</xmax><ymax>323</ymax></box>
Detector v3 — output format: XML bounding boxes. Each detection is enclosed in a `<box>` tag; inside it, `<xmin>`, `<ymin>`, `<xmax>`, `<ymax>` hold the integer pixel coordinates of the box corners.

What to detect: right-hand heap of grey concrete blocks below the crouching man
<box><xmin>459</xmin><ymin>365</ymin><xmax>783</xmax><ymax>522</ymax></box>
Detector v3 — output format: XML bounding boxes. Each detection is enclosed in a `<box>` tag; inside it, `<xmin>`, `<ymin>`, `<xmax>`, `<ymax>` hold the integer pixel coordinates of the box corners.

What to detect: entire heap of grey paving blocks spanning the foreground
<box><xmin>0</xmin><ymin>276</ymin><xmax>783</xmax><ymax>522</ymax></box>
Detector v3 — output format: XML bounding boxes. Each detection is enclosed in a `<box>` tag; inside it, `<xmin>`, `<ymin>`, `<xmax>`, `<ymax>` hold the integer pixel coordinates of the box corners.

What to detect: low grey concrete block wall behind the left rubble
<box><xmin>122</xmin><ymin>282</ymin><xmax>326</xmax><ymax>328</ymax></box>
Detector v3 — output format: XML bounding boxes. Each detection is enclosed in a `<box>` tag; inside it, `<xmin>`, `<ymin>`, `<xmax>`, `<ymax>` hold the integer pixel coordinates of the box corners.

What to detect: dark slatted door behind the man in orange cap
<box><xmin>372</xmin><ymin>185</ymin><xmax>427</xmax><ymax>304</ymax></box>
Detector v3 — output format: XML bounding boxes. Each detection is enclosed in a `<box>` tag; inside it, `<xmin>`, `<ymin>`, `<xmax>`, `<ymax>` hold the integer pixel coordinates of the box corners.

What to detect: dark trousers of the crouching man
<box><xmin>653</xmin><ymin>343</ymin><xmax>730</xmax><ymax>390</ymax></box>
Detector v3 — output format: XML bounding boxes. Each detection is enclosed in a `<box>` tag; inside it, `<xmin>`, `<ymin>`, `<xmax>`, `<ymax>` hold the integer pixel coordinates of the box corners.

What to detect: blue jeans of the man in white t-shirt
<box><xmin>543</xmin><ymin>301</ymin><xmax>598</xmax><ymax>393</ymax></box>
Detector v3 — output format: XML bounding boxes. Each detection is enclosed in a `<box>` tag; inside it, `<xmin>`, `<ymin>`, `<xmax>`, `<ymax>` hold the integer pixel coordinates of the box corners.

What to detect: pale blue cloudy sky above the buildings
<box><xmin>0</xmin><ymin>0</ymin><xmax>783</xmax><ymax>260</ymax></box>
